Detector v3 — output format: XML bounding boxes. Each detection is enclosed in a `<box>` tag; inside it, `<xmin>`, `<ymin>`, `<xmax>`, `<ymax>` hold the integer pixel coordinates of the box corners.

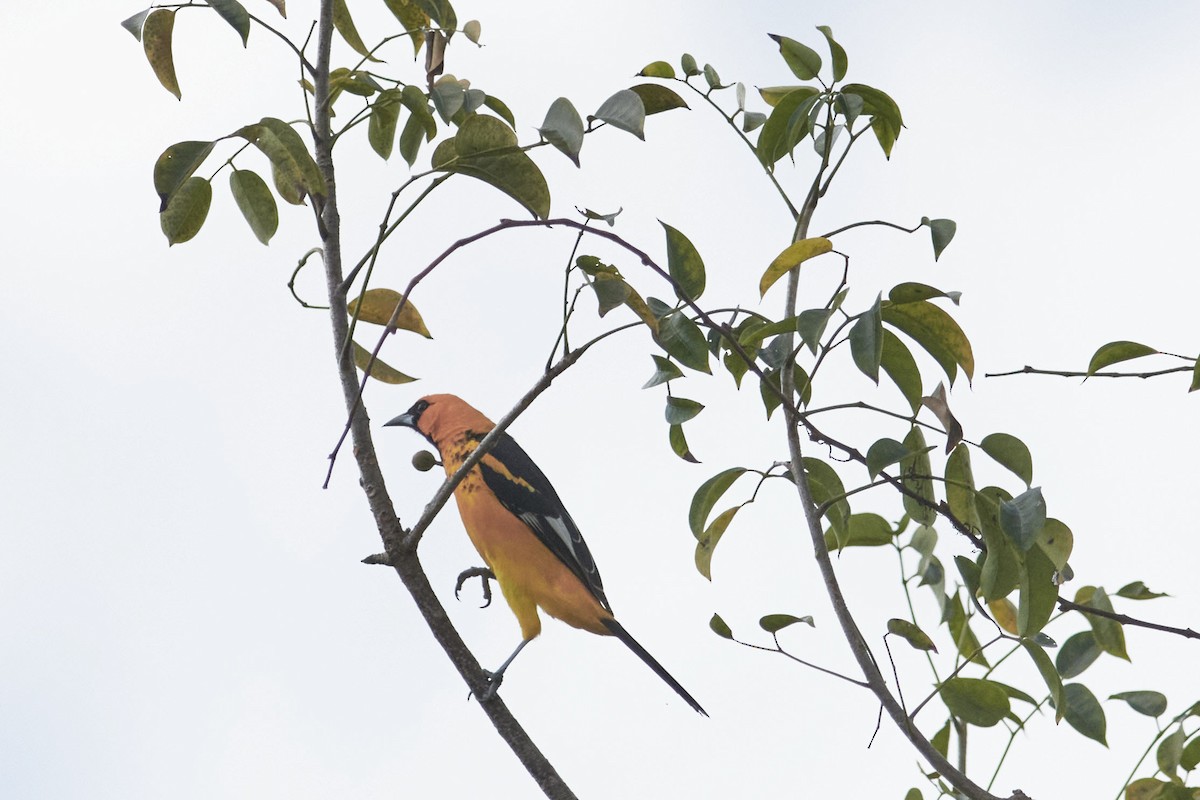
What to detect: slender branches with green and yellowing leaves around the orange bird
<box><xmin>124</xmin><ymin>0</ymin><xmax>1200</xmax><ymax>800</ymax></box>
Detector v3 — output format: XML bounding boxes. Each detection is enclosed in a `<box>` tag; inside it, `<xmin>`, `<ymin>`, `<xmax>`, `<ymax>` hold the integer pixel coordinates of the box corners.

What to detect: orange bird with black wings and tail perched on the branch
<box><xmin>384</xmin><ymin>395</ymin><xmax>708</xmax><ymax>716</ymax></box>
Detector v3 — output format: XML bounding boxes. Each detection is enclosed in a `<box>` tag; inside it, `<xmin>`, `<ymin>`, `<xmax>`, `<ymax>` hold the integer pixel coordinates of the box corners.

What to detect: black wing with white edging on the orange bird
<box><xmin>478</xmin><ymin>433</ymin><xmax>612</xmax><ymax>612</ymax></box>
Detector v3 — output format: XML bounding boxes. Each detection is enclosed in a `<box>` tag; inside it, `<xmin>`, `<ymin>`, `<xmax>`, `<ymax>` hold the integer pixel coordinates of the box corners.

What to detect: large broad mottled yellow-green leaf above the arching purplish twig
<box><xmin>433</xmin><ymin>114</ymin><xmax>550</xmax><ymax>219</ymax></box>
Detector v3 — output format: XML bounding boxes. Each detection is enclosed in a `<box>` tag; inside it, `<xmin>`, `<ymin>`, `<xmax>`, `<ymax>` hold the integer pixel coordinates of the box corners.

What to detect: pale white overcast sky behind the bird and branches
<box><xmin>0</xmin><ymin>0</ymin><xmax>1200</xmax><ymax>800</ymax></box>
